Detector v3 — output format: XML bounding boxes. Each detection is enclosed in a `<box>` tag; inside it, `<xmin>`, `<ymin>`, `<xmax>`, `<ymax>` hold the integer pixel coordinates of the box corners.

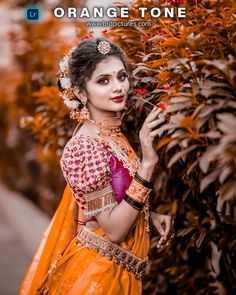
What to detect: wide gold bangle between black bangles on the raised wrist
<box><xmin>126</xmin><ymin>178</ymin><xmax>152</xmax><ymax>204</ymax></box>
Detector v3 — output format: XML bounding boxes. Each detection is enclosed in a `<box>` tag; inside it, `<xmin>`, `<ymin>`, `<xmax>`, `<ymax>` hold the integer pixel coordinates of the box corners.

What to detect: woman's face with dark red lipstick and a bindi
<box><xmin>80</xmin><ymin>56</ymin><xmax>129</xmax><ymax>121</ymax></box>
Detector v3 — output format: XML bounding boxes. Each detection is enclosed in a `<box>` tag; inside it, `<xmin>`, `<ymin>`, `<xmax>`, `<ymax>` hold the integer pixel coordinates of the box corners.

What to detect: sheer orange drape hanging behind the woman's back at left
<box><xmin>19</xmin><ymin>185</ymin><xmax>78</xmax><ymax>295</ymax></box>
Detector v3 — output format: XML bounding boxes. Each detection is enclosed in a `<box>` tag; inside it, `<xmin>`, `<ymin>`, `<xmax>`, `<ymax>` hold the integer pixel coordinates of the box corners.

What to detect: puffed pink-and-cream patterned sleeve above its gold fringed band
<box><xmin>60</xmin><ymin>134</ymin><xmax>111</xmax><ymax>192</ymax></box>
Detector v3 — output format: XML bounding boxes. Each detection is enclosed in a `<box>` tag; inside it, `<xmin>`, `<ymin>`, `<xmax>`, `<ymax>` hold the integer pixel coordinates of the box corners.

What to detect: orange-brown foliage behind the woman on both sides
<box><xmin>0</xmin><ymin>0</ymin><xmax>236</xmax><ymax>294</ymax></box>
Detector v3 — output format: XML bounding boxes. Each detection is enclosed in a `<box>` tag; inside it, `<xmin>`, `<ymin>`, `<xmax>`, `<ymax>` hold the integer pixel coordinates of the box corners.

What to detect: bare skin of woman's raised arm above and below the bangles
<box><xmin>96</xmin><ymin>109</ymin><xmax>163</xmax><ymax>242</ymax></box>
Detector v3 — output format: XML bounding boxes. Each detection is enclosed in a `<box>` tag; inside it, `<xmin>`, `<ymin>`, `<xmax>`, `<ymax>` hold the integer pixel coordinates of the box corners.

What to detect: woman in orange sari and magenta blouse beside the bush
<box><xmin>20</xmin><ymin>38</ymin><xmax>170</xmax><ymax>295</ymax></box>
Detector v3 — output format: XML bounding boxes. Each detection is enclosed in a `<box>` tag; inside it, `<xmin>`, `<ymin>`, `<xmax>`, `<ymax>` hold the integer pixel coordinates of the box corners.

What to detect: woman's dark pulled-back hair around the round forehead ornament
<box><xmin>69</xmin><ymin>38</ymin><xmax>131</xmax><ymax>91</ymax></box>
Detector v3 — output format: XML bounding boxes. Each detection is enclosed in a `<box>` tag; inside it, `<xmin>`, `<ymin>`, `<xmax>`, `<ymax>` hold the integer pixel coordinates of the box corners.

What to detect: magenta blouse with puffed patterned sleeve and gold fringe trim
<box><xmin>61</xmin><ymin>135</ymin><xmax>132</xmax><ymax>218</ymax></box>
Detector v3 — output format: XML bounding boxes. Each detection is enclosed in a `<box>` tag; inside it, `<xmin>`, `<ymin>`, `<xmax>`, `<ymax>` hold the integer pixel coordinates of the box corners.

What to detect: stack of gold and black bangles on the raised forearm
<box><xmin>124</xmin><ymin>173</ymin><xmax>153</xmax><ymax>211</ymax></box>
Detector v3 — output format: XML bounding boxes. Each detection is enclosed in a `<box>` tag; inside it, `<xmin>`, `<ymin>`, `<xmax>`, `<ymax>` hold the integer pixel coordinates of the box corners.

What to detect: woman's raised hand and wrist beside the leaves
<box><xmin>139</xmin><ymin>107</ymin><xmax>165</xmax><ymax>166</ymax></box>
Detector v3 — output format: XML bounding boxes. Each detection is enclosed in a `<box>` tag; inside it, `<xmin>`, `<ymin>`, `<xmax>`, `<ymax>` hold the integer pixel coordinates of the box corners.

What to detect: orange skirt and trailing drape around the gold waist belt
<box><xmin>19</xmin><ymin>186</ymin><xmax>150</xmax><ymax>295</ymax></box>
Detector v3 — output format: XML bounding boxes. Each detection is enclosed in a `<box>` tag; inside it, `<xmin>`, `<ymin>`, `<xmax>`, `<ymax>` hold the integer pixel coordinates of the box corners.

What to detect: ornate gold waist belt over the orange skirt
<box><xmin>77</xmin><ymin>226</ymin><xmax>148</xmax><ymax>279</ymax></box>
